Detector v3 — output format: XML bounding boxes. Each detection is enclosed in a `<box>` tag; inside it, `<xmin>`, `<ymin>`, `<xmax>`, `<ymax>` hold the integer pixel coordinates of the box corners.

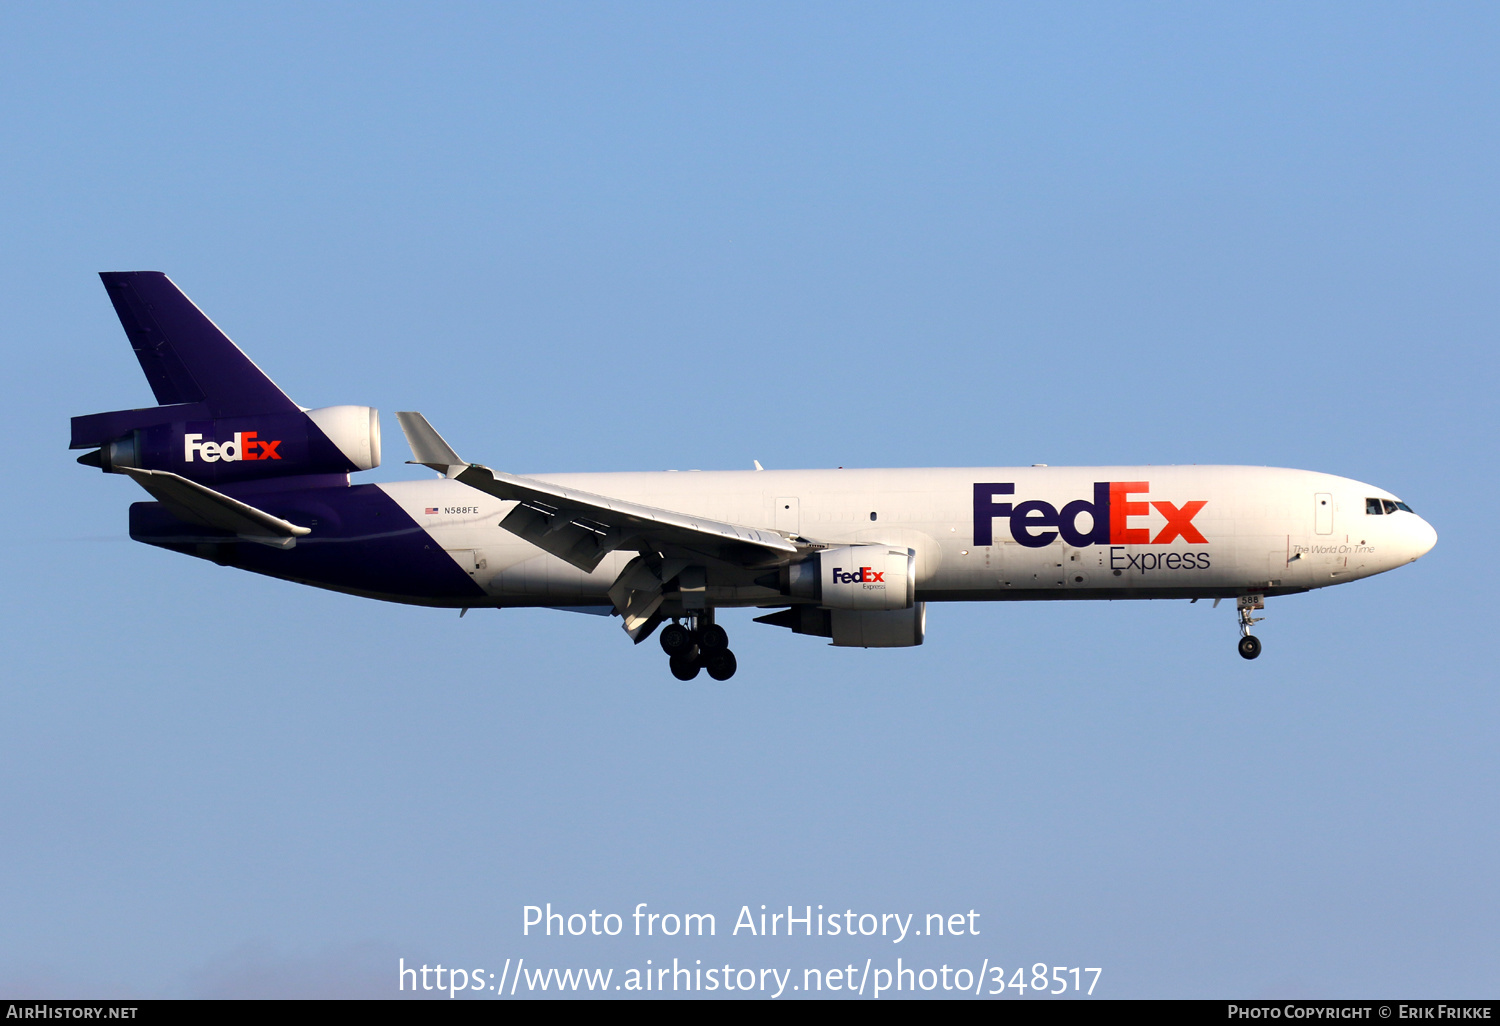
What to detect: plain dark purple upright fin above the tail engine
<box><xmin>99</xmin><ymin>272</ymin><xmax>299</xmax><ymax>417</ymax></box>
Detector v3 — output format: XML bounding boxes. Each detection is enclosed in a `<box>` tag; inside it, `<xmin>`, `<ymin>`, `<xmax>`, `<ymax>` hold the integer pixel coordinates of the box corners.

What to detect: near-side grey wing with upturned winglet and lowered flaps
<box><xmin>396</xmin><ymin>413</ymin><xmax>800</xmax><ymax>573</ymax></box>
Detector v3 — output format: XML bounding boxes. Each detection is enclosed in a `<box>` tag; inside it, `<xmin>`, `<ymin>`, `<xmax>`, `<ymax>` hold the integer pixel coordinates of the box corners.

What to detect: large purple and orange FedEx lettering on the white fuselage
<box><xmin>974</xmin><ymin>482</ymin><xmax>1208</xmax><ymax>549</ymax></box>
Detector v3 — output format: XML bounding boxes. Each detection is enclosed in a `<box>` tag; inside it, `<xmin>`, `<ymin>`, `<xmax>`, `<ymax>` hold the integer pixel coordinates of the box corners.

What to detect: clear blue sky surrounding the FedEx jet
<box><xmin>0</xmin><ymin>3</ymin><xmax>1500</xmax><ymax>998</ymax></box>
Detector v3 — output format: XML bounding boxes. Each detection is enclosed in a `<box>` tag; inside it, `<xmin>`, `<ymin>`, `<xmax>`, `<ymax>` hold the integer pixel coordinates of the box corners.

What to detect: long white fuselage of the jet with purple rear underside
<box><xmin>137</xmin><ymin>467</ymin><xmax>1436</xmax><ymax>608</ymax></box>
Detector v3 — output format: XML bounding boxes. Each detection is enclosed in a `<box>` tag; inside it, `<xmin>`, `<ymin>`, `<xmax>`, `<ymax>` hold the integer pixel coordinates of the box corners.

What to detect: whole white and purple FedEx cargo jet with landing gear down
<box><xmin>72</xmin><ymin>272</ymin><xmax>1437</xmax><ymax>681</ymax></box>
